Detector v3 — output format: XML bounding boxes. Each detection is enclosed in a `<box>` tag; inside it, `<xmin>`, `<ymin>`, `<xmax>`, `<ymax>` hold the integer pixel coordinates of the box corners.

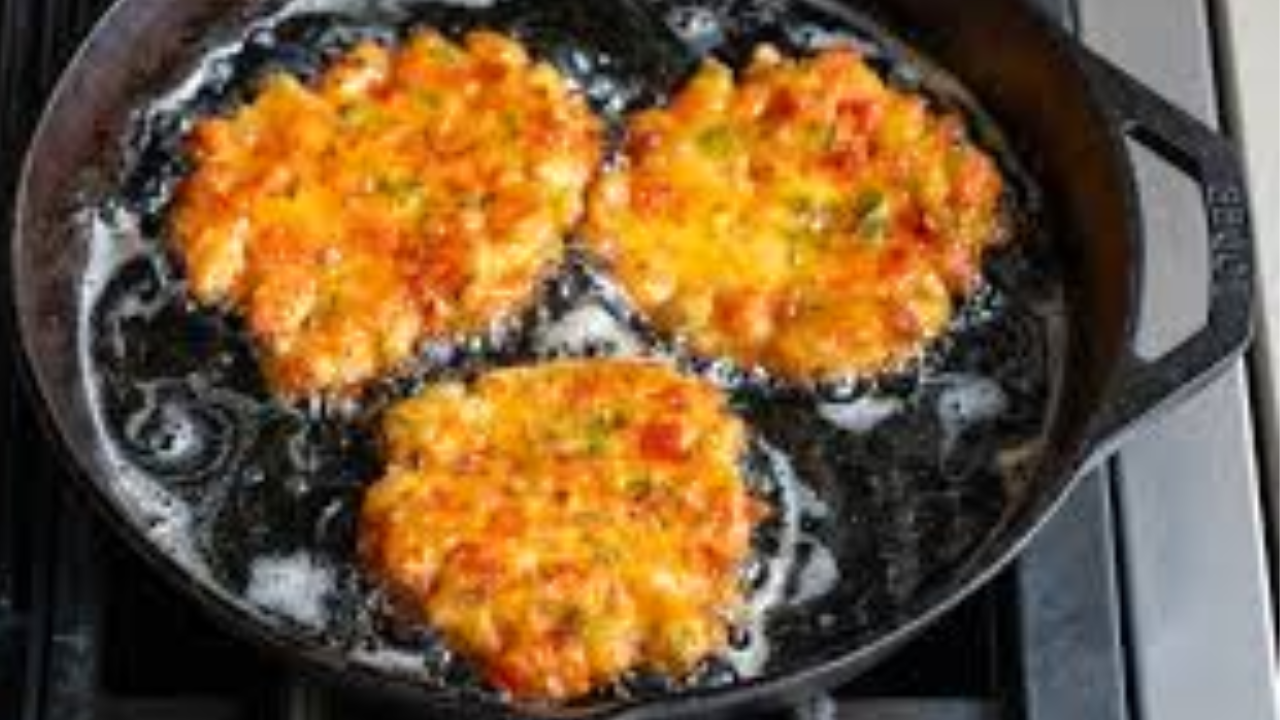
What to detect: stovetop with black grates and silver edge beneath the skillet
<box><xmin>0</xmin><ymin>0</ymin><xmax>1280</xmax><ymax>720</ymax></box>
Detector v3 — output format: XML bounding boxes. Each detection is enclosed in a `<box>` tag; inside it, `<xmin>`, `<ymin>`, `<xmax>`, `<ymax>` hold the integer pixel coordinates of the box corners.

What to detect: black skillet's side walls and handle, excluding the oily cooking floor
<box><xmin>12</xmin><ymin>0</ymin><xmax>1252</xmax><ymax>717</ymax></box>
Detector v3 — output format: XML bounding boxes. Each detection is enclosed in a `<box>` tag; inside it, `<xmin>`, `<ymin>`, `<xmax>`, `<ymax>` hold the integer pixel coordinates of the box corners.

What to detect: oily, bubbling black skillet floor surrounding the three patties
<box><xmin>52</xmin><ymin>0</ymin><xmax>1069</xmax><ymax>710</ymax></box>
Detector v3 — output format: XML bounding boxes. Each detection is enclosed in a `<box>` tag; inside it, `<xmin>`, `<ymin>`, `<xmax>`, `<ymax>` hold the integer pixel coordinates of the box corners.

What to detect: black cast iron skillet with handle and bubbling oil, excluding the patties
<box><xmin>10</xmin><ymin>0</ymin><xmax>1252</xmax><ymax>717</ymax></box>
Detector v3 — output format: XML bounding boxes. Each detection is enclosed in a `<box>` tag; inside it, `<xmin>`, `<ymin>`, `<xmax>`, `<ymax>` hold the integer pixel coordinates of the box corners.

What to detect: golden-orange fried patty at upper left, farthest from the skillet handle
<box><xmin>172</xmin><ymin>32</ymin><xmax>599</xmax><ymax>396</ymax></box>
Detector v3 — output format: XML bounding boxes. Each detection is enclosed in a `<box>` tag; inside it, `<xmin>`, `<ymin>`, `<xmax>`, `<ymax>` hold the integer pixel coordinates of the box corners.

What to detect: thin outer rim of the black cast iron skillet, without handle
<box><xmin>8</xmin><ymin>0</ymin><xmax>1142</xmax><ymax>720</ymax></box>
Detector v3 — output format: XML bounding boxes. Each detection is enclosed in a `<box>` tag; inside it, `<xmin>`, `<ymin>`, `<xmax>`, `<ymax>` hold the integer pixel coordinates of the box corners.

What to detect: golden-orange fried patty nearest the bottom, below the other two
<box><xmin>360</xmin><ymin>360</ymin><xmax>764</xmax><ymax>700</ymax></box>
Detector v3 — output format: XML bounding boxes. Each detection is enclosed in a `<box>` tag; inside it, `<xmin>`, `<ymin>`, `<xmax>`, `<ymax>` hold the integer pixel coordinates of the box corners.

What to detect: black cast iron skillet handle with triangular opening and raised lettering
<box><xmin>1079</xmin><ymin>49</ymin><xmax>1253</xmax><ymax>457</ymax></box>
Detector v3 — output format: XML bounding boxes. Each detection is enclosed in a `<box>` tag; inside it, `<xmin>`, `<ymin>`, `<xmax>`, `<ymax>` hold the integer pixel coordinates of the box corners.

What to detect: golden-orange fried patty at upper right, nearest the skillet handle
<box><xmin>586</xmin><ymin>46</ymin><xmax>1005</xmax><ymax>379</ymax></box>
